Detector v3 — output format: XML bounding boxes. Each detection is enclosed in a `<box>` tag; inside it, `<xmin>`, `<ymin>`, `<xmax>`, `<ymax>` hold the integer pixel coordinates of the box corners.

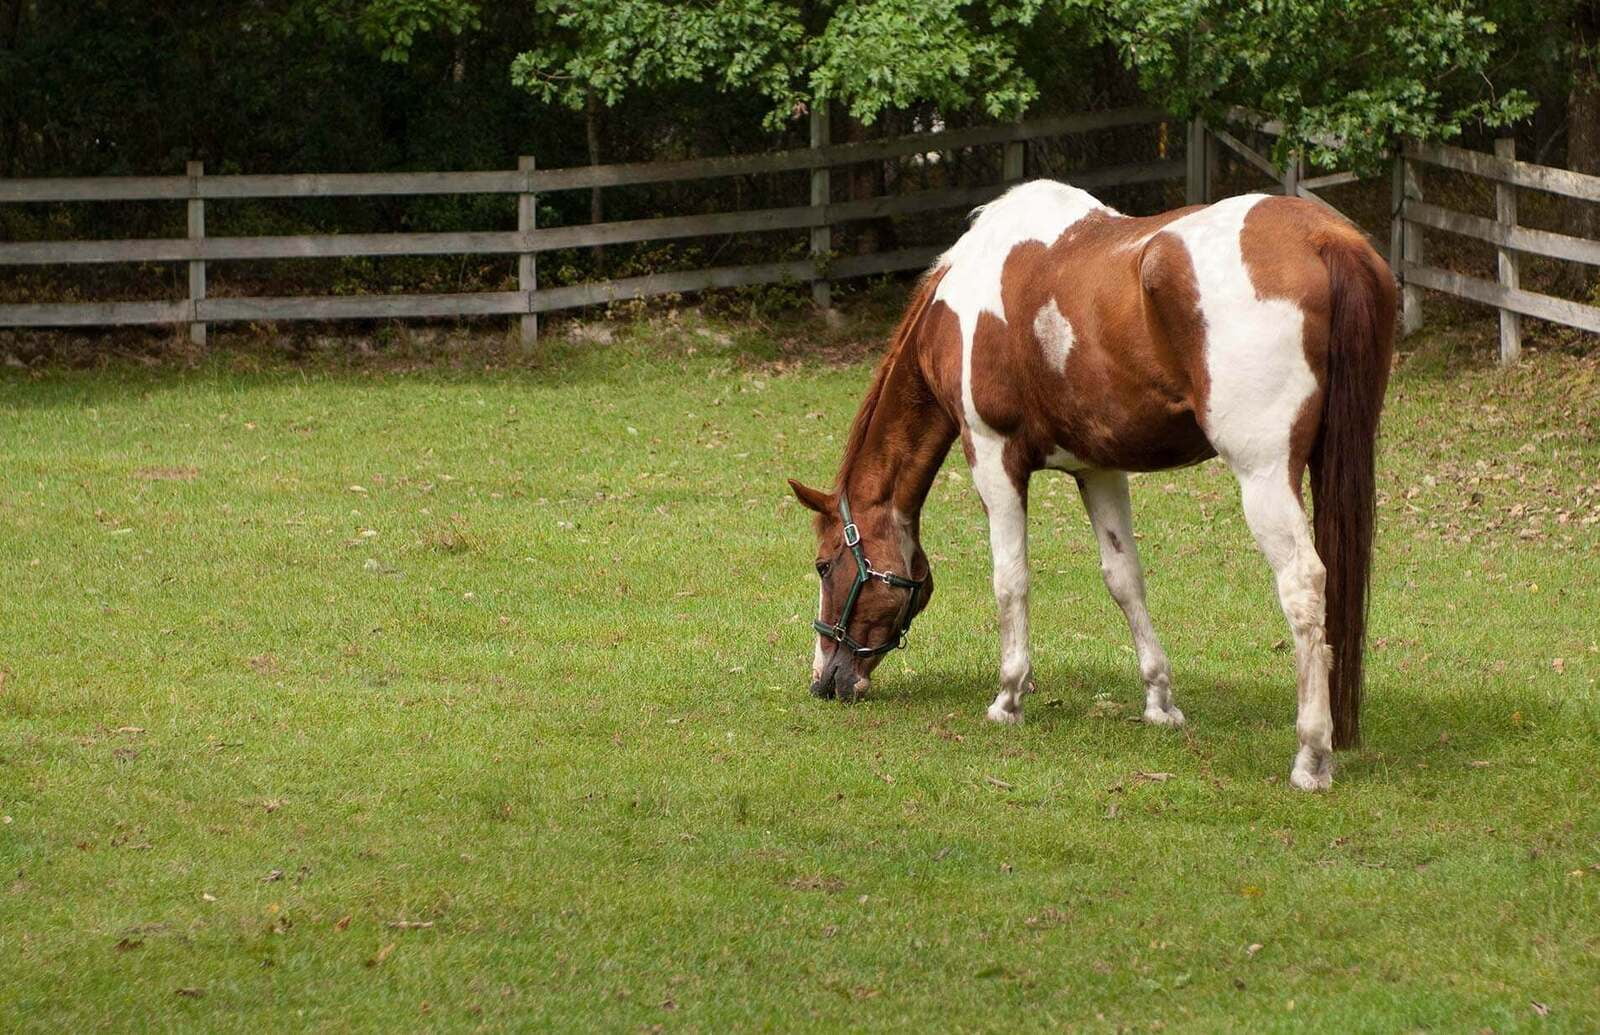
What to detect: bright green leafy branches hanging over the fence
<box><xmin>512</xmin><ymin>0</ymin><xmax>1533</xmax><ymax>174</ymax></box>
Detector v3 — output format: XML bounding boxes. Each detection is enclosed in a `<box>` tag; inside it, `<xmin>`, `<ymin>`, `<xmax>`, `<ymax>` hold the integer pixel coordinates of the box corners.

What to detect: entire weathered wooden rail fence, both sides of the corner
<box><xmin>0</xmin><ymin>107</ymin><xmax>1600</xmax><ymax>362</ymax></box>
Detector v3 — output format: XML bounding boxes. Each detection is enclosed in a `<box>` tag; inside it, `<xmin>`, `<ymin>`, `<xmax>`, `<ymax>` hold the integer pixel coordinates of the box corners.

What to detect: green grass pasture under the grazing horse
<box><xmin>0</xmin><ymin>311</ymin><xmax>1600</xmax><ymax>1032</ymax></box>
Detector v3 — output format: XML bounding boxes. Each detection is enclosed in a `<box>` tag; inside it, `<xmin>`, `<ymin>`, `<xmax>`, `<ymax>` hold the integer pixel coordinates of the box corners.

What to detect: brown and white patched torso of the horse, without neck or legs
<box><xmin>931</xmin><ymin>181</ymin><xmax>1388</xmax><ymax>470</ymax></box>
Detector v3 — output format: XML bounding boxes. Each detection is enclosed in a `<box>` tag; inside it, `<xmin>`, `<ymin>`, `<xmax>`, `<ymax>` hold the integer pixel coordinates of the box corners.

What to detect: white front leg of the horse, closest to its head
<box><xmin>970</xmin><ymin>437</ymin><xmax>1034</xmax><ymax>723</ymax></box>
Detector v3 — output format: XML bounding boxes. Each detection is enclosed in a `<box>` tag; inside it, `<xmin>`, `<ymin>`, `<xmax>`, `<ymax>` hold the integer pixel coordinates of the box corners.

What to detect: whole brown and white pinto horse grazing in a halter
<box><xmin>790</xmin><ymin>181</ymin><xmax>1395</xmax><ymax>790</ymax></box>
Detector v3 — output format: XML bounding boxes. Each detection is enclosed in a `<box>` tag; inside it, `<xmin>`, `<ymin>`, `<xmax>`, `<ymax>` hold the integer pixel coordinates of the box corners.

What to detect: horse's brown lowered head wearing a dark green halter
<box><xmin>789</xmin><ymin>478</ymin><xmax>933</xmax><ymax>701</ymax></box>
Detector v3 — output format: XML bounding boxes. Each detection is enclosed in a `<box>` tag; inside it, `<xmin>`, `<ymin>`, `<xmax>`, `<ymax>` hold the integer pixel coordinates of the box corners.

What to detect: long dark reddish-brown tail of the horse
<box><xmin>1310</xmin><ymin>235</ymin><xmax>1395</xmax><ymax>747</ymax></box>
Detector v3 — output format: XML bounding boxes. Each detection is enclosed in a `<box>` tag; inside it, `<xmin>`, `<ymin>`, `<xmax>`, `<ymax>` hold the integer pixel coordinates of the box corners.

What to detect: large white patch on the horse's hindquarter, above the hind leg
<box><xmin>1163</xmin><ymin>194</ymin><xmax>1317</xmax><ymax>472</ymax></box>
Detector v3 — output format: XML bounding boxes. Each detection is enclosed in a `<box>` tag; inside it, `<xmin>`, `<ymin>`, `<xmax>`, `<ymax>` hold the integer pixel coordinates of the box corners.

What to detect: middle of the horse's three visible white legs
<box><xmin>1078</xmin><ymin>470</ymin><xmax>1184</xmax><ymax>726</ymax></box>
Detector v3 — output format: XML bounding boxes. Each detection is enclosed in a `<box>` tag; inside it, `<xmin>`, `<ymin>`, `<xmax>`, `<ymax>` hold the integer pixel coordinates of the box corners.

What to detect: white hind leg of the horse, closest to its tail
<box><xmin>1235</xmin><ymin>464</ymin><xmax>1333</xmax><ymax>790</ymax></box>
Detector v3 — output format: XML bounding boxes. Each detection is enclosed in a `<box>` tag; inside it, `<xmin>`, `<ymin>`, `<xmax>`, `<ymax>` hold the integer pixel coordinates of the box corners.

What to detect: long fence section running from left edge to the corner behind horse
<box><xmin>0</xmin><ymin>109</ymin><xmax>1184</xmax><ymax>342</ymax></box>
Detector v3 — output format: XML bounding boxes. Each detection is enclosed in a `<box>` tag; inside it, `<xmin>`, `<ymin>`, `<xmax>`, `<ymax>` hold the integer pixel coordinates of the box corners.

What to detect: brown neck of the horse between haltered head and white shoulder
<box><xmin>842</xmin><ymin>349</ymin><xmax>957</xmax><ymax>526</ymax></box>
